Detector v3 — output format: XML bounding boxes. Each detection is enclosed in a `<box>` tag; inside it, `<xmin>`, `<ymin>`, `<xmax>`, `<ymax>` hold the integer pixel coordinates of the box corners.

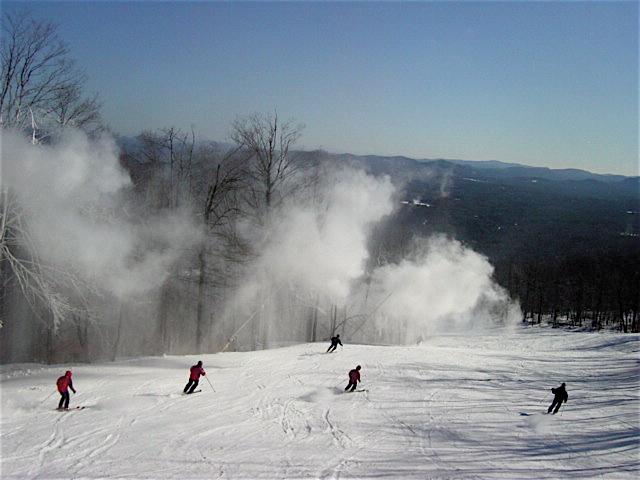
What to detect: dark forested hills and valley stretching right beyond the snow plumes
<box><xmin>344</xmin><ymin>153</ymin><xmax>640</xmax><ymax>331</ymax></box>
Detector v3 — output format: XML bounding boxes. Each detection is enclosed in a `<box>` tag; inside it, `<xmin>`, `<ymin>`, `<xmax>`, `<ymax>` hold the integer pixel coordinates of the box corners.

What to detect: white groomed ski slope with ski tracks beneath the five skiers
<box><xmin>0</xmin><ymin>328</ymin><xmax>640</xmax><ymax>480</ymax></box>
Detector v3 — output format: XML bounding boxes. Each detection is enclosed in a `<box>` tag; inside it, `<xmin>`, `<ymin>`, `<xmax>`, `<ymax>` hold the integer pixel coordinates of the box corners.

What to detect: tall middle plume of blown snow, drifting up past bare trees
<box><xmin>228</xmin><ymin>170</ymin><xmax>393</xmax><ymax>325</ymax></box>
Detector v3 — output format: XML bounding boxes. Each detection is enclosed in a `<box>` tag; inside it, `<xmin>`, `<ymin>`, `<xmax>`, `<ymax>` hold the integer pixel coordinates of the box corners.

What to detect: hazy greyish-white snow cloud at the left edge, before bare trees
<box><xmin>2</xmin><ymin>131</ymin><xmax>198</xmax><ymax>297</ymax></box>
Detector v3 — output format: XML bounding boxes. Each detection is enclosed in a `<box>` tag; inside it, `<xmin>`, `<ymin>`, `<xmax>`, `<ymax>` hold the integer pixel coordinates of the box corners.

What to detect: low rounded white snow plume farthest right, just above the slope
<box><xmin>360</xmin><ymin>236</ymin><xmax>519</xmax><ymax>342</ymax></box>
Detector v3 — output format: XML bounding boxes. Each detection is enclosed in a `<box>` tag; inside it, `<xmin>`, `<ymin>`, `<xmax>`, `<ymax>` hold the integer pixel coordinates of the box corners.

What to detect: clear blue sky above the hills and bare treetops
<box><xmin>2</xmin><ymin>1</ymin><xmax>639</xmax><ymax>175</ymax></box>
